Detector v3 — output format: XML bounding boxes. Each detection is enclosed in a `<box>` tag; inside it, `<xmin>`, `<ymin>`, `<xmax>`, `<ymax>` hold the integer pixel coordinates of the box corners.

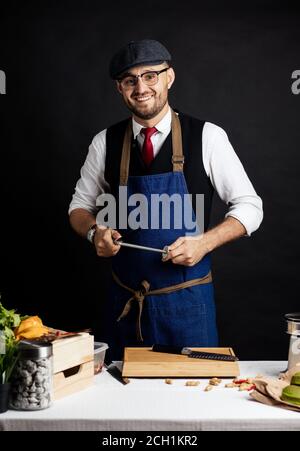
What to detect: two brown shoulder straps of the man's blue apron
<box><xmin>120</xmin><ymin>109</ymin><xmax>184</xmax><ymax>186</ymax></box>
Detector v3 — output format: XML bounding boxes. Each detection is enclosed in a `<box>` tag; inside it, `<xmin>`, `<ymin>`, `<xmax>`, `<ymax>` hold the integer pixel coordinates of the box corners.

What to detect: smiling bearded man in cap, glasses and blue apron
<box><xmin>69</xmin><ymin>40</ymin><xmax>263</xmax><ymax>359</ymax></box>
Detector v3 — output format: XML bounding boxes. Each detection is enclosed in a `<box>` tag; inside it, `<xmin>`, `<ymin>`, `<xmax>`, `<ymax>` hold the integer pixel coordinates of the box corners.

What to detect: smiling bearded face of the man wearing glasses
<box><xmin>117</xmin><ymin>63</ymin><xmax>175</xmax><ymax>120</ymax></box>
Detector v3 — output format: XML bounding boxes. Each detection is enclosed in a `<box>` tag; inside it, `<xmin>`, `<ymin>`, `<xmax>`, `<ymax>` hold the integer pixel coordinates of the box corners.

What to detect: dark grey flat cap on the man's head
<box><xmin>109</xmin><ymin>39</ymin><xmax>171</xmax><ymax>80</ymax></box>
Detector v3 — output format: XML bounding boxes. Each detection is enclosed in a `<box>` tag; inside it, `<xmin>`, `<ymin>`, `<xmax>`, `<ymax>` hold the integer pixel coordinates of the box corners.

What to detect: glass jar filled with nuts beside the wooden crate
<box><xmin>9</xmin><ymin>341</ymin><xmax>53</xmax><ymax>410</ymax></box>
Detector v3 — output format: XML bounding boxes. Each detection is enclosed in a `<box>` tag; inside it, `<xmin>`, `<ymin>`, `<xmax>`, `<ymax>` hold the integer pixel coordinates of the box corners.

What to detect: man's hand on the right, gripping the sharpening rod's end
<box><xmin>163</xmin><ymin>235</ymin><xmax>209</xmax><ymax>266</ymax></box>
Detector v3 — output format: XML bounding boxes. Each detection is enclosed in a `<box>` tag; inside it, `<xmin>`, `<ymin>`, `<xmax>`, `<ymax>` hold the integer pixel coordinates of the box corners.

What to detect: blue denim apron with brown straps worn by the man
<box><xmin>110</xmin><ymin>111</ymin><xmax>218</xmax><ymax>360</ymax></box>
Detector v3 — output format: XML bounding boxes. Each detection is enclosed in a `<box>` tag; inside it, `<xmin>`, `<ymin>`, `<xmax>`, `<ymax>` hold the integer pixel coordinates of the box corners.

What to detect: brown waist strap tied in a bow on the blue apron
<box><xmin>112</xmin><ymin>271</ymin><xmax>212</xmax><ymax>341</ymax></box>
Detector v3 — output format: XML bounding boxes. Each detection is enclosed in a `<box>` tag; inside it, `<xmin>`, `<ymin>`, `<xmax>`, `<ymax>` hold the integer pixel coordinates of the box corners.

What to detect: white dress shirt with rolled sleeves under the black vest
<box><xmin>69</xmin><ymin>109</ymin><xmax>263</xmax><ymax>236</ymax></box>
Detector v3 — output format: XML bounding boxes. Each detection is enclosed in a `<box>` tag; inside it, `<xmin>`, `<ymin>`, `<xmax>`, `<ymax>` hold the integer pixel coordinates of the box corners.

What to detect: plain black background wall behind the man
<box><xmin>0</xmin><ymin>0</ymin><xmax>300</xmax><ymax>360</ymax></box>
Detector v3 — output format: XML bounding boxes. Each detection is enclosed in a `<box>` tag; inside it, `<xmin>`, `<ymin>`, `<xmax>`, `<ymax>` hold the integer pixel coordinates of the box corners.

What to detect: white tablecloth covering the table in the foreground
<box><xmin>0</xmin><ymin>362</ymin><xmax>300</xmax><ymax>431</ymax></box>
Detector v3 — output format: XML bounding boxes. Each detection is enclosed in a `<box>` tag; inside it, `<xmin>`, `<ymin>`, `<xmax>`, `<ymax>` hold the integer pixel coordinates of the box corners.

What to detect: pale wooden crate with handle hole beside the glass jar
<box><xmin>53</xmin><ymin>333</ymin><xmax>94</xmax><ymax>400</ymax></box>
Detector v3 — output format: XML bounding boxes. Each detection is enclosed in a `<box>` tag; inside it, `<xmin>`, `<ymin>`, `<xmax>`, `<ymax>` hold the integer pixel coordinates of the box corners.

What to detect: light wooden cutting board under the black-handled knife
<box><xmin>122</xmin><ymin>348</ymin><xmax>240</xmax><ymax>377</ymax></box>
